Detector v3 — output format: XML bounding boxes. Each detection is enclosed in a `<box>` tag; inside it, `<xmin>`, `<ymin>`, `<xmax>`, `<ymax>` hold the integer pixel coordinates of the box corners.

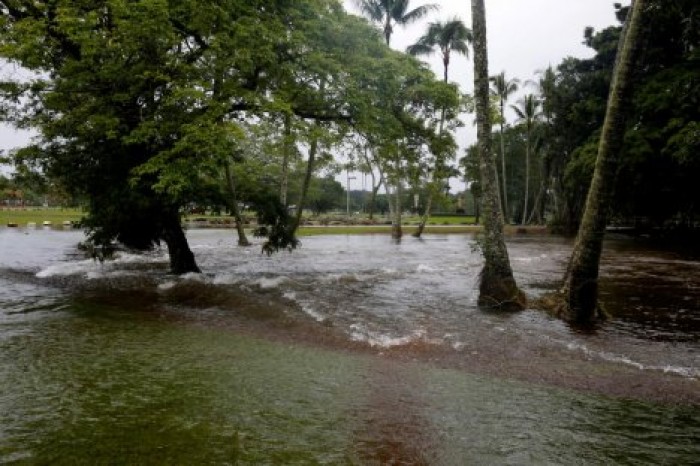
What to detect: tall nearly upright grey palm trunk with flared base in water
<box><xmin>471</xmin><ymin>0</ymin><xmax>525</xmax><ymax>310</ymax></box>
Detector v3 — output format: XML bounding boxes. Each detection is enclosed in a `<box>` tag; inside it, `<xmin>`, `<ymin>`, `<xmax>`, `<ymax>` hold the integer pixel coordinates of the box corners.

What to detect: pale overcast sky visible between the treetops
<box><xmin>0</xmin><ymin>0</ymin><xmax>629</xmax><ymax>189</ymax></box>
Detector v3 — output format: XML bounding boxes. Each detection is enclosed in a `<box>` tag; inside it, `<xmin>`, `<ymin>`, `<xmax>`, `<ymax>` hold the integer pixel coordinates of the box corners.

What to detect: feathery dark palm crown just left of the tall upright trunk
<box><xmin>407</xmin><ymin>18</ymin><xmax>472</xmax><ymax>82</ymax></box>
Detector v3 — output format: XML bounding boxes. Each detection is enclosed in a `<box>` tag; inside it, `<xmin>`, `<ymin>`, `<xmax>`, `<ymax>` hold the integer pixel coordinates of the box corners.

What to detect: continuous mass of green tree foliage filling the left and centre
<box><xmin>0</xmin><ymin>0</ymin><xmax>457</xmax><ymax>272</ymax></box>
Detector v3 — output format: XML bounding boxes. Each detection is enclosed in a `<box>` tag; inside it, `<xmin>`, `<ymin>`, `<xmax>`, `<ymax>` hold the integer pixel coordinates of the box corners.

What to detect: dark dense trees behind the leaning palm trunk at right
<box><xmin>468</xmin><ymin>0</ymin><xmax>700</xmax><ymax>233</ymax></box>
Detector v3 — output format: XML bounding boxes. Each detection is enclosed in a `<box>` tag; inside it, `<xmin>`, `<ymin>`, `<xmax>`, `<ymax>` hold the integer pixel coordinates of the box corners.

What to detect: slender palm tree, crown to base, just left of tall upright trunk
<box><xmin>407</xmin><ymin>18</ymin><xmax>472</xmax><ymax>238</ymax></box>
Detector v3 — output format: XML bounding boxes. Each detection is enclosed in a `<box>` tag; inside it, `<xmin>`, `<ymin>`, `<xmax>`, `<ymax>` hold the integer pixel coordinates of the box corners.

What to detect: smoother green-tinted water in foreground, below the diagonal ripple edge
<box><xmin>0</xmin><ymin>302</ymin><xmax>700</xmax><ymax>465</ymax></box>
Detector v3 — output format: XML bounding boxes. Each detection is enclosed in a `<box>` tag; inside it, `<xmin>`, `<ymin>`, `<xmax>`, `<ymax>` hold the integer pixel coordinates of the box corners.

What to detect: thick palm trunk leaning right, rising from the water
<box><xmin>562</xmin><ymin>0</ymin><xmax>647</xmax><ymax>324</ymax></box>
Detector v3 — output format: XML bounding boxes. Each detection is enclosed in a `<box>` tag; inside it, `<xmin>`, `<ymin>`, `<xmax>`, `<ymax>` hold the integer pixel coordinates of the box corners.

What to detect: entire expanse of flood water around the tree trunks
<box><xmin>0</xmin><ymin>229</ymin><xmax>700</xmax><ymax>465</ymax></box>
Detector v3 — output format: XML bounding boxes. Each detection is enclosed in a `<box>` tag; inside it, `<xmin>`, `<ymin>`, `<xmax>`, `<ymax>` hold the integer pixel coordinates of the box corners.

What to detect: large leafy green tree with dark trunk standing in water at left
<box><xmin>0</xmin><ymin>0</ymin><xmax>394</xmax><ymax>273</ymax></box>
